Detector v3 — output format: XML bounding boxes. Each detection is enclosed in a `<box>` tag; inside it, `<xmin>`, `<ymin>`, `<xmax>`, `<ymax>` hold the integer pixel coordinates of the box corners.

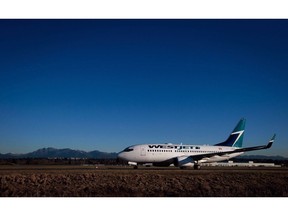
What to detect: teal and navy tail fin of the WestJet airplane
<box><xmin>215</xmin><ymin>118</ymin><xmax>246</xmax><ymax>148</ymax></box>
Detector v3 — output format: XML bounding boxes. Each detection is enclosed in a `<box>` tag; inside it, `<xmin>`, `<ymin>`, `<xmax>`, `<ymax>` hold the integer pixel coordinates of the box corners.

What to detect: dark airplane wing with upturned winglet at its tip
<box><xmin>190</xmin><ymin>134</ymin><xmax>276</xmax><ymax>161</ymax></box>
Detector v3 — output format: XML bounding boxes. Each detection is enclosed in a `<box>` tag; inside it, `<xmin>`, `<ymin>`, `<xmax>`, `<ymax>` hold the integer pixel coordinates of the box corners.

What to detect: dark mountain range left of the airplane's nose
<box><xmin>0</xmin><ymin>148</ymin><xmax>117</xmax><ymax>159</ymax></box>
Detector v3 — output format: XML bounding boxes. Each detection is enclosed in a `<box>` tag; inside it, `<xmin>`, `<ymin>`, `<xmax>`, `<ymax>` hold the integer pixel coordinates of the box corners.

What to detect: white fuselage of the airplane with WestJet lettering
<box><xmin>118</xmin><ymin>144</ymin><xmax>243</xmax><ymax>163</ymax></box>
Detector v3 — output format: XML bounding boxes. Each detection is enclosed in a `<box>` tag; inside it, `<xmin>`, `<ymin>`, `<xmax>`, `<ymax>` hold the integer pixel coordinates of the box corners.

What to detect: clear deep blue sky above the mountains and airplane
<box><xmin>0</xmin><ymin>19</ymin><xmax>288</xmax><ymax>157</ymax></box>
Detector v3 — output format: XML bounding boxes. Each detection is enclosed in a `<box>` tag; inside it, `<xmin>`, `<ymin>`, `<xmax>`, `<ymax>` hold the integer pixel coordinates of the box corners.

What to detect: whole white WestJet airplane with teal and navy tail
<box><xmin>118</xmin><ymin>118</ymin><xmax>276</xmax><ymax>169</ymax></box>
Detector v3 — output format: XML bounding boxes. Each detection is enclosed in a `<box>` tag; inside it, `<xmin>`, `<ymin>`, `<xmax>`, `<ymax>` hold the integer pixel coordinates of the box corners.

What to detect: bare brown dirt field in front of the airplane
<box><xmin>0</xmin><ymin>165</ymin><xmax>288</xmax><ymax>197</ymax></box>
